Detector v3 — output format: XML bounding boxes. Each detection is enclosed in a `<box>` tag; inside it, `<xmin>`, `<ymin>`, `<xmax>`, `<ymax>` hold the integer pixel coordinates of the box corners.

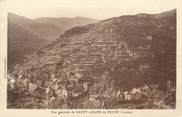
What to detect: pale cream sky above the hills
<box><xmin>5</xmin><ymin>0</ymin><xmax>178</xmax><ymax>20</ymax></box>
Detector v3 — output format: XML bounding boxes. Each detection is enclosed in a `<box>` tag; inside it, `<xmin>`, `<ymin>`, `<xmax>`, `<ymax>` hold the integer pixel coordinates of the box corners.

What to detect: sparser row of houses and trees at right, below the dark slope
<box><xmin>85</xmin><ymin>77</ymin><xmax>175</xmax><ymax>108</ymax></box>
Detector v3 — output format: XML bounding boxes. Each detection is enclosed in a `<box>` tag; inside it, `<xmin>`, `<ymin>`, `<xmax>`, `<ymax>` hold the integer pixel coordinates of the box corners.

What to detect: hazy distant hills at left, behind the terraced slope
<box><xmin>8</xmin><ymin>13</ymin><xmax>96</xmax><ymax>68</ymax></box>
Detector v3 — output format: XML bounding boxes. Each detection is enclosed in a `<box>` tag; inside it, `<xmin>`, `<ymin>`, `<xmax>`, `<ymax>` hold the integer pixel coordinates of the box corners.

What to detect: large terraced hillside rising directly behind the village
<box><xmin>7</xmin><ymin>10</ymin><xmax>176</xmax><ymax>108</ymax></box>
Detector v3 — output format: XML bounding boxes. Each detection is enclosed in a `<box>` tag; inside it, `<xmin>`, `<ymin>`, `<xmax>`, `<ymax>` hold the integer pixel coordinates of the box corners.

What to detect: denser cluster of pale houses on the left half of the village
<box><xmin>8</xmin><ymin>68</ymin><xmax>88</xmax><ymax>108</ymax></box>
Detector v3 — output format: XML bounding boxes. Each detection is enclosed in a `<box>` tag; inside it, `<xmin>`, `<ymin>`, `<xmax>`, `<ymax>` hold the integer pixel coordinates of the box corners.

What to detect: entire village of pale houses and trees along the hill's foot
<box><xmin>8</xmin><ymin>66</ymin><xmax>175</xmax><ymax>109</ymax></box>
